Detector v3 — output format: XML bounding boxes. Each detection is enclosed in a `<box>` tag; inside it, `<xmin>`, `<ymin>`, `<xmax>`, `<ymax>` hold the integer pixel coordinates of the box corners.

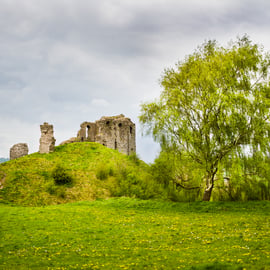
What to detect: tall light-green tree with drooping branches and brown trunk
<box><xmin>140</xmin><ymin>35</ymin><xmax>270</xmax><ymax>201</ymax></box>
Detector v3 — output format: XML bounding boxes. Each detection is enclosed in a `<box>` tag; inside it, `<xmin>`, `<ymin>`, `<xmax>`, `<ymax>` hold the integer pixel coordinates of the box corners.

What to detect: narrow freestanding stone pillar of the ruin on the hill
<box><xmin>39</xmin><ymin>122</ymin><xmax>55</xmax><ymax>154</ymax></box>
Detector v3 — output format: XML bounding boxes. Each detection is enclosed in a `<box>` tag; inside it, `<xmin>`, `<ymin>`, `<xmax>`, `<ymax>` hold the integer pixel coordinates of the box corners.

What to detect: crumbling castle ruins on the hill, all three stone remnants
<box><xmin>7</xmin><ymin>114</ymin><xmax>136</xmax><ymax>159</ymax></box>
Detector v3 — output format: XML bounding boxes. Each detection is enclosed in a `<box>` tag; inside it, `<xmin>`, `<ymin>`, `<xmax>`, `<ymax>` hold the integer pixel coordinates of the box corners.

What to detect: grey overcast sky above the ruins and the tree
<box><xmin>0</xmin><ymin>0</ymin><xmax>270</xmax><ymax>162</ymax></box>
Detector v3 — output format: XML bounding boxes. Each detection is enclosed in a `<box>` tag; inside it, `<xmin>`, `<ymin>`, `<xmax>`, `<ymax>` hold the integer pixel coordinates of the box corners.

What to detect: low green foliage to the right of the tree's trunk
<box><xmin>213</xmin><ymin>151</ymin><xmax>270</xmax><ymax>201</ymax></box>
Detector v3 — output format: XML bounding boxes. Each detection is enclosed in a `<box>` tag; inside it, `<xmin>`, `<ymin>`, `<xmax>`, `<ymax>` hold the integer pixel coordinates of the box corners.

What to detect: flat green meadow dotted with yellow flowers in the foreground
<box><xmin>0</xmin><ymin>198</ymin><xmax>270</xmax><ymax>270</ymax></box>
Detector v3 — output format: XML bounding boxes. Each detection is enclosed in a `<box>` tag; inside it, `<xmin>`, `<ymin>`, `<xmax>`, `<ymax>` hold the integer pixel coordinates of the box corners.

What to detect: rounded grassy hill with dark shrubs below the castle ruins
<box><xmin>0</xmin><ymin>142</ymin><xmax>160</xmax><ymax>206</ymax></box>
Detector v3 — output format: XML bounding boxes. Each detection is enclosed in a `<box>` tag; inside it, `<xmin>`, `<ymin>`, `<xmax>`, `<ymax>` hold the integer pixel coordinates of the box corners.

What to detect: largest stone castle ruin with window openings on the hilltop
<box><xmin>77</xmin><ymin>114</ymin><xmax>136</xmax><ymax>155</ymax></box>
